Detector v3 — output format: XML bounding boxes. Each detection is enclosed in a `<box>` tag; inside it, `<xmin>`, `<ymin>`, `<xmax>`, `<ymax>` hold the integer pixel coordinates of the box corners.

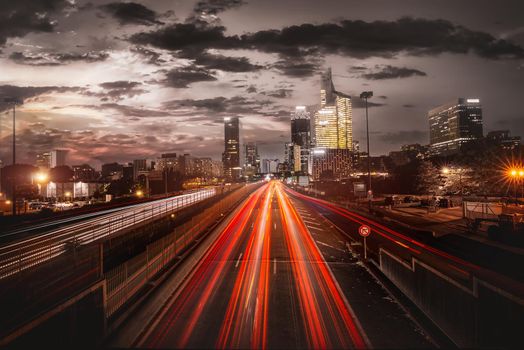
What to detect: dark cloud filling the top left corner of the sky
<box><xmin>0</xmin><ymin>0</ymin><xmax>73</xmax><ymax>45</ymax></box>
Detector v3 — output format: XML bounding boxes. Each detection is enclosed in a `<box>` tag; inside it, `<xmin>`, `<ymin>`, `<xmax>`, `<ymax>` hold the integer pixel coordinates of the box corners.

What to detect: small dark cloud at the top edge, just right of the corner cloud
<box><xmin>99</xmin><ymin>2</ymin><xmax>163</xmax><ymax>26</ymax></box>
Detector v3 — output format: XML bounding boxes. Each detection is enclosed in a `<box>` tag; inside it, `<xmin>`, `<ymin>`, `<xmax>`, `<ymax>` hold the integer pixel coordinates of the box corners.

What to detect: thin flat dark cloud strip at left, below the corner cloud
<box><xmin>9</xmin><ymin>51</ymin><xmax>109</xmax><ymax>66</ymax></box>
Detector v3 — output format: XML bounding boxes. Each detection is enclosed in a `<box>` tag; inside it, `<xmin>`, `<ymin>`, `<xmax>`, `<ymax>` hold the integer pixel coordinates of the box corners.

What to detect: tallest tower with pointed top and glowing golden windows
<box><xmin>315</xmin><ymin>69</ymin><xmax>353</xmax><ymax>150</ymax></box>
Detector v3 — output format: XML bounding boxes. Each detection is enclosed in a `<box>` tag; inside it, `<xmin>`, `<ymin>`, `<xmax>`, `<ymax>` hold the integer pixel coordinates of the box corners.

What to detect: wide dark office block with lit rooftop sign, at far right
<box><xmin>428</xmin><ymin>98</ymin><xmax>482</xmax><ymax>155</ymax></box>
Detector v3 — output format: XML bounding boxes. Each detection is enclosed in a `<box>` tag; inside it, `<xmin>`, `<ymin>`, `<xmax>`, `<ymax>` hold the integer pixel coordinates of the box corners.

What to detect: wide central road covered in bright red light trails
<box><xmin>135</xmin><ymin>181</ymin><xmax>432</xmax><ymax>349</ymax></box>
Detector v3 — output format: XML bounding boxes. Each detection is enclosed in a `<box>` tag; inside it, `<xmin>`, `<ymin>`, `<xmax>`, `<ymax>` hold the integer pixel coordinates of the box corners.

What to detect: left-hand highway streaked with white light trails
<box><xmin>0</xmin><ymin>188</ymin><xmax>216</xmax><ymax>279</ymax></box>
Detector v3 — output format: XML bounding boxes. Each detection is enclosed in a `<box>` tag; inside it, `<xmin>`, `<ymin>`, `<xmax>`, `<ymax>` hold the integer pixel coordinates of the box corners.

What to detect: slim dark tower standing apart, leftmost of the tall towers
<box><xmin>222</xmin><ymin>117</ymin><xmax>241</xmax><ymax>181</ymax></box>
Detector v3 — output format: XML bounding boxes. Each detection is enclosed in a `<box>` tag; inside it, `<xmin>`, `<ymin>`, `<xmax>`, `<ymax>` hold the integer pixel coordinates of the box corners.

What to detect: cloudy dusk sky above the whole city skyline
<box><xmin>0</xmin><ymin>0</ymin><xmax>524</xmax><ymax>168</ymax></box>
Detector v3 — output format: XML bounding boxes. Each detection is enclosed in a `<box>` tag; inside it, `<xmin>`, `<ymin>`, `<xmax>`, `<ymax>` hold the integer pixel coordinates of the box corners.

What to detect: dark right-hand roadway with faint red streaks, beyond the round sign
<box><xmin>286</xmin><ymin>188</ymin><xmax>524</xmax><ymax>295</ymax></box>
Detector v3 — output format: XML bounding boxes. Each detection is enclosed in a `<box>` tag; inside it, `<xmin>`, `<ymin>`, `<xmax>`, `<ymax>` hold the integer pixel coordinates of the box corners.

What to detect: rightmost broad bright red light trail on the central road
<box><xmin>276</xmin><ymin>185</ymin><xmax>367</xmax><ymax>348</ymax></box>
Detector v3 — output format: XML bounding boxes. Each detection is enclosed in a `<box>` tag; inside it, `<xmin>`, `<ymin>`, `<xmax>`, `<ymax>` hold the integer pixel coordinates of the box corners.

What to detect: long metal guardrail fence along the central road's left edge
<box><xmin>105</xmin><ymin>185</ymin><xmax>256</xmax><ymax>318</ymax></box>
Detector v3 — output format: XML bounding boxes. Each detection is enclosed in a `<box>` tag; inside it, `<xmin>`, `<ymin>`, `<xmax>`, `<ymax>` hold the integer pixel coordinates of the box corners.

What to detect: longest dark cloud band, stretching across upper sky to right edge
<box><xmin>130</xmin><ymin>17</ymin><xmax>524</xmax><ymax>63</ymax></box>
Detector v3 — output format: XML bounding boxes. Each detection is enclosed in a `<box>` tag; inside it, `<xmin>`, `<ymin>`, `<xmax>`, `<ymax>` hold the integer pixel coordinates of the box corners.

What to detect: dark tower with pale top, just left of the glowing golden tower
<box><xmin>289</xmin><ymin>106</ymin><xmax>311</xmax><ymax>174</ymax></box>
